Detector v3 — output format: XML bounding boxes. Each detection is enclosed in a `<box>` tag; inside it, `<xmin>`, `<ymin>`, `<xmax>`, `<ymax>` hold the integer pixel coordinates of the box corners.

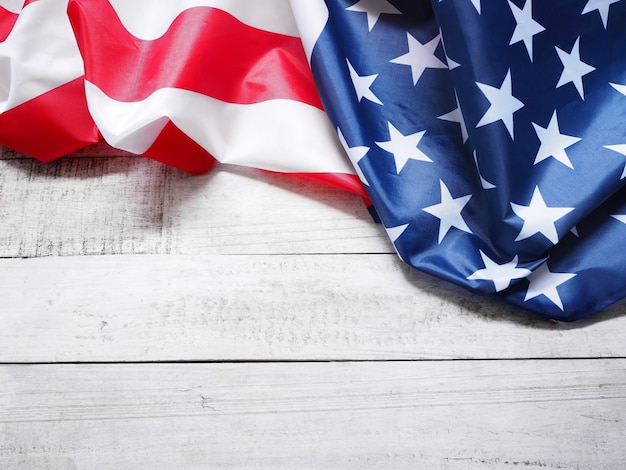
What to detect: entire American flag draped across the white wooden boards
<box><xmin>0</xmin><ymin>0</ymin><xmax>626</xmax><ymax>320</ymax></box>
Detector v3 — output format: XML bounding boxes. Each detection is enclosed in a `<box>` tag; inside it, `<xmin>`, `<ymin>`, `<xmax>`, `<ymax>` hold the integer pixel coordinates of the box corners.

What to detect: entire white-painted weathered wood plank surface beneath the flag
<box><xmin>0</xmin><ymin>149</ymin><xmax>626</xmax><ymax>469</ymax></box>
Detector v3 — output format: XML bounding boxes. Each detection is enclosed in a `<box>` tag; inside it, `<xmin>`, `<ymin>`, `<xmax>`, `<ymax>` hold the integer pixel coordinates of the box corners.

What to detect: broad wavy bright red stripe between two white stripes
<box><xmin>68</xmin><ymin>0</ymin><xmax>322</xmax><ymax>109</ymax></box>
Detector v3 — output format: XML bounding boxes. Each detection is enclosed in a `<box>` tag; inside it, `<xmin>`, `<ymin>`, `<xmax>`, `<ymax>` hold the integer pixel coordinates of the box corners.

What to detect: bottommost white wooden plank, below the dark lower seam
<box><xmin>0</xmin><ymin>360</ymin><xmax>626</xmax><ymax>470</ymax></box>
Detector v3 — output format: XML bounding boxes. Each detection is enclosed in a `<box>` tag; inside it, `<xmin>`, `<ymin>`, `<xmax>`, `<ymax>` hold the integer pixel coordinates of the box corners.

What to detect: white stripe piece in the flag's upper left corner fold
<box><xmin>0</xmin><ymin>0</ymin><xmax>83</xmax><ymax>113</ymax></box>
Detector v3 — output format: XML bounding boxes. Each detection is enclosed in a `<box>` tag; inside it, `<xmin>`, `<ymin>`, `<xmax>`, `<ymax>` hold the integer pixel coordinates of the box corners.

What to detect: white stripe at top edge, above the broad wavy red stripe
<box><xmin>109</xmin><ymin>0</ymin><xmax>299</xmax><ymax>40</ymax></box>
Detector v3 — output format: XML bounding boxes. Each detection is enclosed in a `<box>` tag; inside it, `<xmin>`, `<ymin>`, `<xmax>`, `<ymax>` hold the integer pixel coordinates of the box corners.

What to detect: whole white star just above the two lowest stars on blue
<box><xmin>511</xmin><ymin>186</ymin><xmax>574</xmax><ymax>244</ymax></box>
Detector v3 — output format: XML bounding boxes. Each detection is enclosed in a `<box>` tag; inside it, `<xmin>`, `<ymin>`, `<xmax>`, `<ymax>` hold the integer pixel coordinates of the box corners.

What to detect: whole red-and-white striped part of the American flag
<box><xmin>0</xmin><ymin>0</ymin><xmax>365</xmax><ymax>196</ymax></box>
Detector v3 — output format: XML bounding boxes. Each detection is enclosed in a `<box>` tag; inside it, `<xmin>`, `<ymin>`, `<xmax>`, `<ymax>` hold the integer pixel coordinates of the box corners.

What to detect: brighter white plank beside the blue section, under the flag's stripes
<box><xmin>164</xmin><ymin>165</ymin><xmax>386</xmax><ymax>254</ymax></box>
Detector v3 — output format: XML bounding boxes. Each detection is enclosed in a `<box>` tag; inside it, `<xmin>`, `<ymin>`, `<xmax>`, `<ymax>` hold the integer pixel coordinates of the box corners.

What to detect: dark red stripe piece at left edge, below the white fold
<box><xmin>0</xmin><ymin>78</ymin><xmax>100</xmax><ymax>162</ymax></box>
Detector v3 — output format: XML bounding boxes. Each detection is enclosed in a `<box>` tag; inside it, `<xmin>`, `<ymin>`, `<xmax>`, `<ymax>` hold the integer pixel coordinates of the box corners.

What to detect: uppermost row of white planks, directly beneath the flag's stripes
<box><xmin>0</xmin><ymin>157</ymin><xmax>393</xmax><ymax>257</ymax></box>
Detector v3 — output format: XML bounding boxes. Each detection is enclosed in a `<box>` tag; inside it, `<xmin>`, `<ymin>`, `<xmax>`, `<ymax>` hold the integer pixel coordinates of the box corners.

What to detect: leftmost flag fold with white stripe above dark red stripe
<box><xmin>0</xmin><ymin>0</ymin><xmax>99</xmax><ymax>161</ymax></box>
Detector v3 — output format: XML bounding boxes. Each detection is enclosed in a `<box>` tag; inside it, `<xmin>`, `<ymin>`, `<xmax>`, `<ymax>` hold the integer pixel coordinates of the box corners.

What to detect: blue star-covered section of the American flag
<box><xmin>292</xmin><ymin>0</ymin><xmax>626</xmax><ymax>320</ymax></box>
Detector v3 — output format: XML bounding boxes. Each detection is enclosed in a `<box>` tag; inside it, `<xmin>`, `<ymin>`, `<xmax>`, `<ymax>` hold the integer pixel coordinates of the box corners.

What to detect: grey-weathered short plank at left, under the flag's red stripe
<box><xmin>0</xmin><ymin>157</ymin><xmax>168</xmax><ymax>257</ymax></box>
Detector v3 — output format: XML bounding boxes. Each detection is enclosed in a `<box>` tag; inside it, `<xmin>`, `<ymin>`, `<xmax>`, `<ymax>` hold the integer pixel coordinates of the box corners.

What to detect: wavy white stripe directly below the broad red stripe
<box><xmin>85</xmin><ymin>82</ymin><xmax>354</xmax><ymax>174</ymax></box>
